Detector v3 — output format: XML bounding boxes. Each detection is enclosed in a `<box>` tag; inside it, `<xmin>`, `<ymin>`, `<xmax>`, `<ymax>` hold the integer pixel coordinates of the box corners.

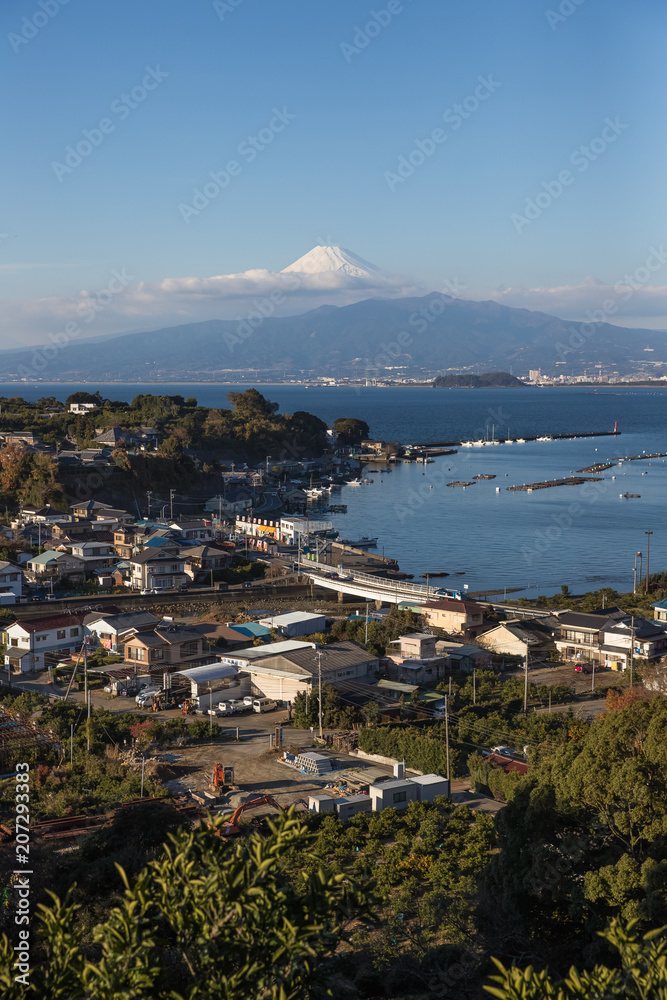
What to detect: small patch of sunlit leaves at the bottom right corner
<box><xmin>484</xmin><ymin>921</ymin><xmax>667</xmax><ymax>1000</ymax></box>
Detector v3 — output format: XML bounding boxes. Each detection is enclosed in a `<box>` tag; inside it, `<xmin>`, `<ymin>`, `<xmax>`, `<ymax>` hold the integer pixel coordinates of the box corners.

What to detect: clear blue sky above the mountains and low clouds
<box><xmin>0</xmin><ymin>0</ymin><xmax>667</xmax><ymax>346</ymax></box>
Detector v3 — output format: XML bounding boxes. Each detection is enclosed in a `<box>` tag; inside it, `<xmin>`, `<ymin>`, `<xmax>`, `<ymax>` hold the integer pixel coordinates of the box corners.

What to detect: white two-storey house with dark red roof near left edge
<box><xmin>5</xmin><ymin>614</ymin><xmax>86</xmax><ymax>674</ymax></box>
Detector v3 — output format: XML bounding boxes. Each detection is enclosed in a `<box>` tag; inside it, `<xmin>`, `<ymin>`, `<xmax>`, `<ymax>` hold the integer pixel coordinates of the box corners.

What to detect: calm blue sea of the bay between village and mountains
<box><xmin>5</xmin><ymin>383</ymin><xmax>667</xmax><ymax>596</ymax></box>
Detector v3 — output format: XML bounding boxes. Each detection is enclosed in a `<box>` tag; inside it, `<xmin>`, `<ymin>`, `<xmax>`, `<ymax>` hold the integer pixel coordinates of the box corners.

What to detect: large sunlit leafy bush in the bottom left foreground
<box><xmin>0</xmin><ymin>815</ymin><xmax>369</xmax><ymax>1000</ymax></box>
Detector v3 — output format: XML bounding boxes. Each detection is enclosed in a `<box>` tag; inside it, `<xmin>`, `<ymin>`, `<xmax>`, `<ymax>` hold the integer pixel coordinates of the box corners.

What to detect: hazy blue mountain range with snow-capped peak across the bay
<box><xmin>6</xmin><ymin>247</ymin><xmax>667</xmax><ymax>382</ymax></box>
